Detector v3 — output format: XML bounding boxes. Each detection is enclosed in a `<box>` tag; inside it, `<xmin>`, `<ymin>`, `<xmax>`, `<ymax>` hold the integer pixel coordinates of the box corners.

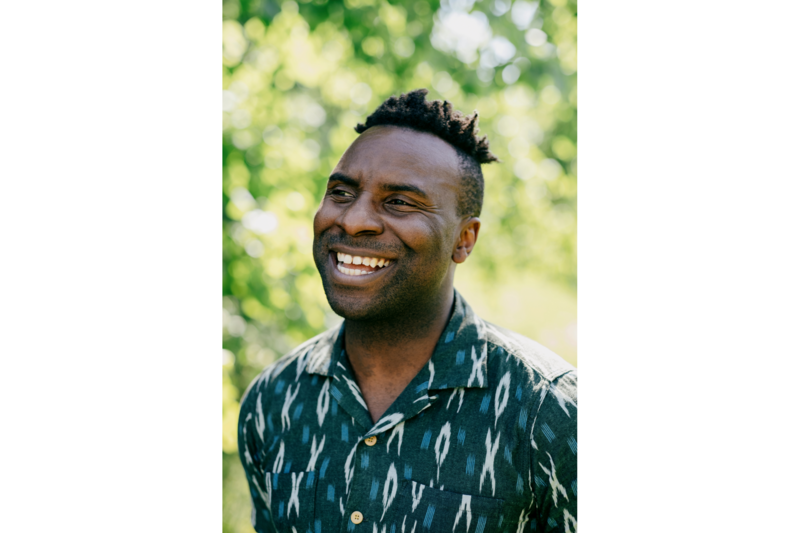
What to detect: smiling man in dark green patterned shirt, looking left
<box><xmin>239</xmin><ymin>89</ymin><xmax>577</xmax><ymax>533</ymax></box>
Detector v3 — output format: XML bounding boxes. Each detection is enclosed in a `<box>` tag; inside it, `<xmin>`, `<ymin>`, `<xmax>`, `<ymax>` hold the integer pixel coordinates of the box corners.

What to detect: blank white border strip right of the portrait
<box><xmin>578</xmin><ymin>1</ymin><xmax>800</xmax><ymax>532</ymax></box>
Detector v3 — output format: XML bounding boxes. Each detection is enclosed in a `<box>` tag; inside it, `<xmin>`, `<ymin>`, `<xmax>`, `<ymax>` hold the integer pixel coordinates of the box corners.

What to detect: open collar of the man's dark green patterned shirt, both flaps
<box><xmin>306</xmin><ymin>291</ymin><xmax>488</xmax><ymax>390</ymax></box>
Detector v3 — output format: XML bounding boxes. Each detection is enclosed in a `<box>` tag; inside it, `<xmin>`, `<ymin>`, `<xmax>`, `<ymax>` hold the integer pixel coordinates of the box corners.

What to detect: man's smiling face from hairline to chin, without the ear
<box><xmin>314</xmin><ymin>126</ymin><xmax>463</xmax><ymax>320</ymax></box>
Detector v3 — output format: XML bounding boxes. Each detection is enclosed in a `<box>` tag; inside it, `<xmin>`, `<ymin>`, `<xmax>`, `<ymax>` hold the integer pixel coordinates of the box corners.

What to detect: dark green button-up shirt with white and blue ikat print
<box><xmin>239</xmin><ymin>292</ymin><xmax>578</xmax><ymax>533</ymax></box>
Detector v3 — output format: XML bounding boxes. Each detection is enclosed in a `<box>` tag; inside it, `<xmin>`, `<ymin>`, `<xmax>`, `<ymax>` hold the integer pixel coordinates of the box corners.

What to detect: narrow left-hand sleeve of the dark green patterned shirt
<box><xmin>238</xmin><ymin>380</ymin><xmax>269</xmax><ymax>533</ymax></box>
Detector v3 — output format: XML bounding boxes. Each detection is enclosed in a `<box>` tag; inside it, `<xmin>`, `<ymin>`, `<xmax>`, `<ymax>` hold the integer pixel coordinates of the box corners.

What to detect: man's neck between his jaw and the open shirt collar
<box><xmin>345</xmin><ymin>285</ymin><xmax>455</xmax><ymax>384</ymax></box>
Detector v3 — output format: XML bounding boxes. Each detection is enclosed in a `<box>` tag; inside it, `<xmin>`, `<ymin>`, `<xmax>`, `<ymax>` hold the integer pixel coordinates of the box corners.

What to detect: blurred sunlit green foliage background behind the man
<box><xmin>222</xmin><ymin>0</ymin><xmax>577</xmax><ymax>533</ymax></box>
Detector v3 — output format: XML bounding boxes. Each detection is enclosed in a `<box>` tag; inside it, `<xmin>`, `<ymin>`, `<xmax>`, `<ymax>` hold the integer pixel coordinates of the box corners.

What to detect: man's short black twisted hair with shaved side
<box><xmin>355</xmin><ymin>89</ymin><xmax>499</xmax><ymax>216</ymax></box>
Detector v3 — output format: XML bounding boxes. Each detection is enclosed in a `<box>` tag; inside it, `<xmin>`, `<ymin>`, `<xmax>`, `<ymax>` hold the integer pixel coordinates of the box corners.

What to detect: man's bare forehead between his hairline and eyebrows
<box><xmin>336</xmin><ymin>126</ymin><xmax>460</xmax><ymax>189</ymax></box>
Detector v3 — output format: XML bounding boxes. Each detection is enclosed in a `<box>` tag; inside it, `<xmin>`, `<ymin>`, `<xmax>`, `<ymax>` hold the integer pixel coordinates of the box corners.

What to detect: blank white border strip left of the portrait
<box><xmin>0</xmin><ymin>0</ymin><xmax>222</xmax><ymax>533</ymax></box>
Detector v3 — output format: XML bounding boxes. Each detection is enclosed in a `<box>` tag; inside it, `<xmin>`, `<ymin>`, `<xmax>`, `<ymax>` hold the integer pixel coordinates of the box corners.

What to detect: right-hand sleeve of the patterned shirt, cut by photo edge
<box><xmin>531</xmin><ymin>371</ymin><xmax>578</xmax><ymax>533</ymax></box>
